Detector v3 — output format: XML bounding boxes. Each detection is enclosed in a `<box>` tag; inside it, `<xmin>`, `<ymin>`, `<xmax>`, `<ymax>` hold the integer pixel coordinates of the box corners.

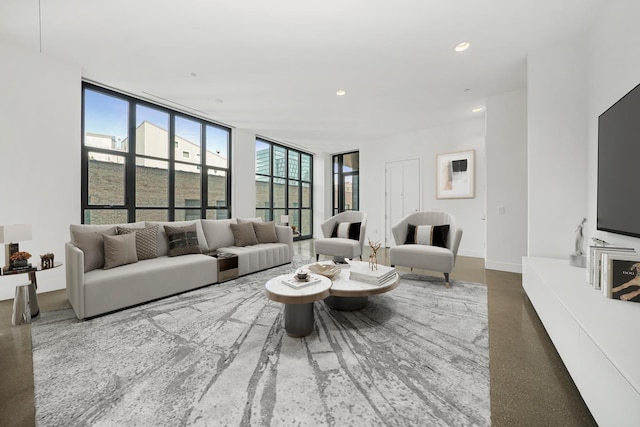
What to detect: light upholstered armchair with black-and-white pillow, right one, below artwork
<box><xmin>389</xmin><ymin>211</ymin><xmax>462</xmax><ymax>287</ymax></box>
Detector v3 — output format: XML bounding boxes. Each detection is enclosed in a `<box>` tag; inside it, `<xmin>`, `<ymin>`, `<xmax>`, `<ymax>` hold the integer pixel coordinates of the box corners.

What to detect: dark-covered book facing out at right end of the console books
<box><xmin>602</xmin><ymin>252</ymin><xmax>640</xmax><ymax>302</ymax></box>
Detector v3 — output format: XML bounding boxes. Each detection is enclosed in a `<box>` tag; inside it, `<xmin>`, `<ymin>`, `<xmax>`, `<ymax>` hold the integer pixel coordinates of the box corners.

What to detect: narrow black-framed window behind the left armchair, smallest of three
<box><xmin>333</xmin><ymin>151</ymin><xmax>360</xmax><ymax>215</ymax></box>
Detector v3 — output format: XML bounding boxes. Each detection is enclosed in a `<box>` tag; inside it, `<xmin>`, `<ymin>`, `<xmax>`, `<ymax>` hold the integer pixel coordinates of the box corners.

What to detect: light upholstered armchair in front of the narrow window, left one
<box><xmin>315</xmin><ymin>211</ymin><xmax>367</xmax><ymax>261</ymax></box>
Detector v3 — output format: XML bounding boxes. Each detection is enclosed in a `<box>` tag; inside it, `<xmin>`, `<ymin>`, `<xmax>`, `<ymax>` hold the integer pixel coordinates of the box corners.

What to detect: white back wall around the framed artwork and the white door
<box><xmin>360</xmin><ymin>117</ymin><xmax>486</xmax><ymax>257</ymax></box>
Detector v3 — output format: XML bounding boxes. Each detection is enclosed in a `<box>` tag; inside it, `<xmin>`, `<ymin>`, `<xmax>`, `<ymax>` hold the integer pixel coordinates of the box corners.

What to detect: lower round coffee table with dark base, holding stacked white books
<box><xmin>303</xmin><ymin>261</ymin><xmax>400</xmax><ymax>311</ymax></box>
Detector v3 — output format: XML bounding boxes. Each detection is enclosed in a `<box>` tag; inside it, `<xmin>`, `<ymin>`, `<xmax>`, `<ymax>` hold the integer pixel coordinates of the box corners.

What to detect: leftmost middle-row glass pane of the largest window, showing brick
<box><xmin>88</xmin><ymin>151</ymin><xmax>125</xmax><ymax>206</ymax></box>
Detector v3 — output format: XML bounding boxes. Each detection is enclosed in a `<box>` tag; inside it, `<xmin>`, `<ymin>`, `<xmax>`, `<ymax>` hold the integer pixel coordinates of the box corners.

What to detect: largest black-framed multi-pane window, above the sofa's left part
<box><xmin>82</xmin><ymin>83</ymin><xmax>231</xmax><ymax>224</ymax></box>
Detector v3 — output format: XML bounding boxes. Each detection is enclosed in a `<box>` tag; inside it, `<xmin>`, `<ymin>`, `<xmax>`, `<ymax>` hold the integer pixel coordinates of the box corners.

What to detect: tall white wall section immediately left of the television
<box><xmin>527</xmin><ymin>35</ymin><xmax>588</xmax><ymax>259</ymax></box>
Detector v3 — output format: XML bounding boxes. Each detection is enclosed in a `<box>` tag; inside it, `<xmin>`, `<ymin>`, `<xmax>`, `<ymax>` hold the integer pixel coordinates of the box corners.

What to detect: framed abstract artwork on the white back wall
<box><xmin>436</xmin><ymin>150</ymin><xmax>475</xmax><ymax>199</ymax></box>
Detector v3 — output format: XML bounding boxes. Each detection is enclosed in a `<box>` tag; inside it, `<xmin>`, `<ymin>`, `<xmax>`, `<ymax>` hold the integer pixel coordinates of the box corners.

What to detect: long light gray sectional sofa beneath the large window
<box><xmin>65</xmin><ymin>218</ymin><xmax>293</xmax><ymax>319</ymax></box>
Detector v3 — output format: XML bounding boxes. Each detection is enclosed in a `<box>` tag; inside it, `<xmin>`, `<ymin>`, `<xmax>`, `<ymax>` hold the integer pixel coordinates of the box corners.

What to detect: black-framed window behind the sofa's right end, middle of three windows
<box><xmin>256</xmin><ymin>138</ymin><xmax>313</xmax><ymax>239</ymax></box>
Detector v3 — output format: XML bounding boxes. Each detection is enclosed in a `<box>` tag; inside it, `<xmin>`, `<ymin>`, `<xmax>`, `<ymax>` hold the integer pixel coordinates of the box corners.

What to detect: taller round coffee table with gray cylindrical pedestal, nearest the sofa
<box><xmin>264</xmin><ymin>274</ymin><xmax>331</xmax><ymax>337</ymax></box>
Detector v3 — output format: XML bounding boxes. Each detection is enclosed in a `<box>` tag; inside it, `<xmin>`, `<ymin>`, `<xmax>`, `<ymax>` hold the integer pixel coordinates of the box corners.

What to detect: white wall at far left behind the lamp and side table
<box><xmin>0</xmin><ymin>42</ymin><xmax>81</xmax><ymax>300</ymax></box>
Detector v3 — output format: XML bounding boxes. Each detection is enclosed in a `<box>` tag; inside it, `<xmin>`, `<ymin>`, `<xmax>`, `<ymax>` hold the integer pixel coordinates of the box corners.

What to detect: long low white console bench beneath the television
<box><xmin>522</xmin><ymin>257</ymin><xmax>640</xmax><ymax>427</ymax></box>
